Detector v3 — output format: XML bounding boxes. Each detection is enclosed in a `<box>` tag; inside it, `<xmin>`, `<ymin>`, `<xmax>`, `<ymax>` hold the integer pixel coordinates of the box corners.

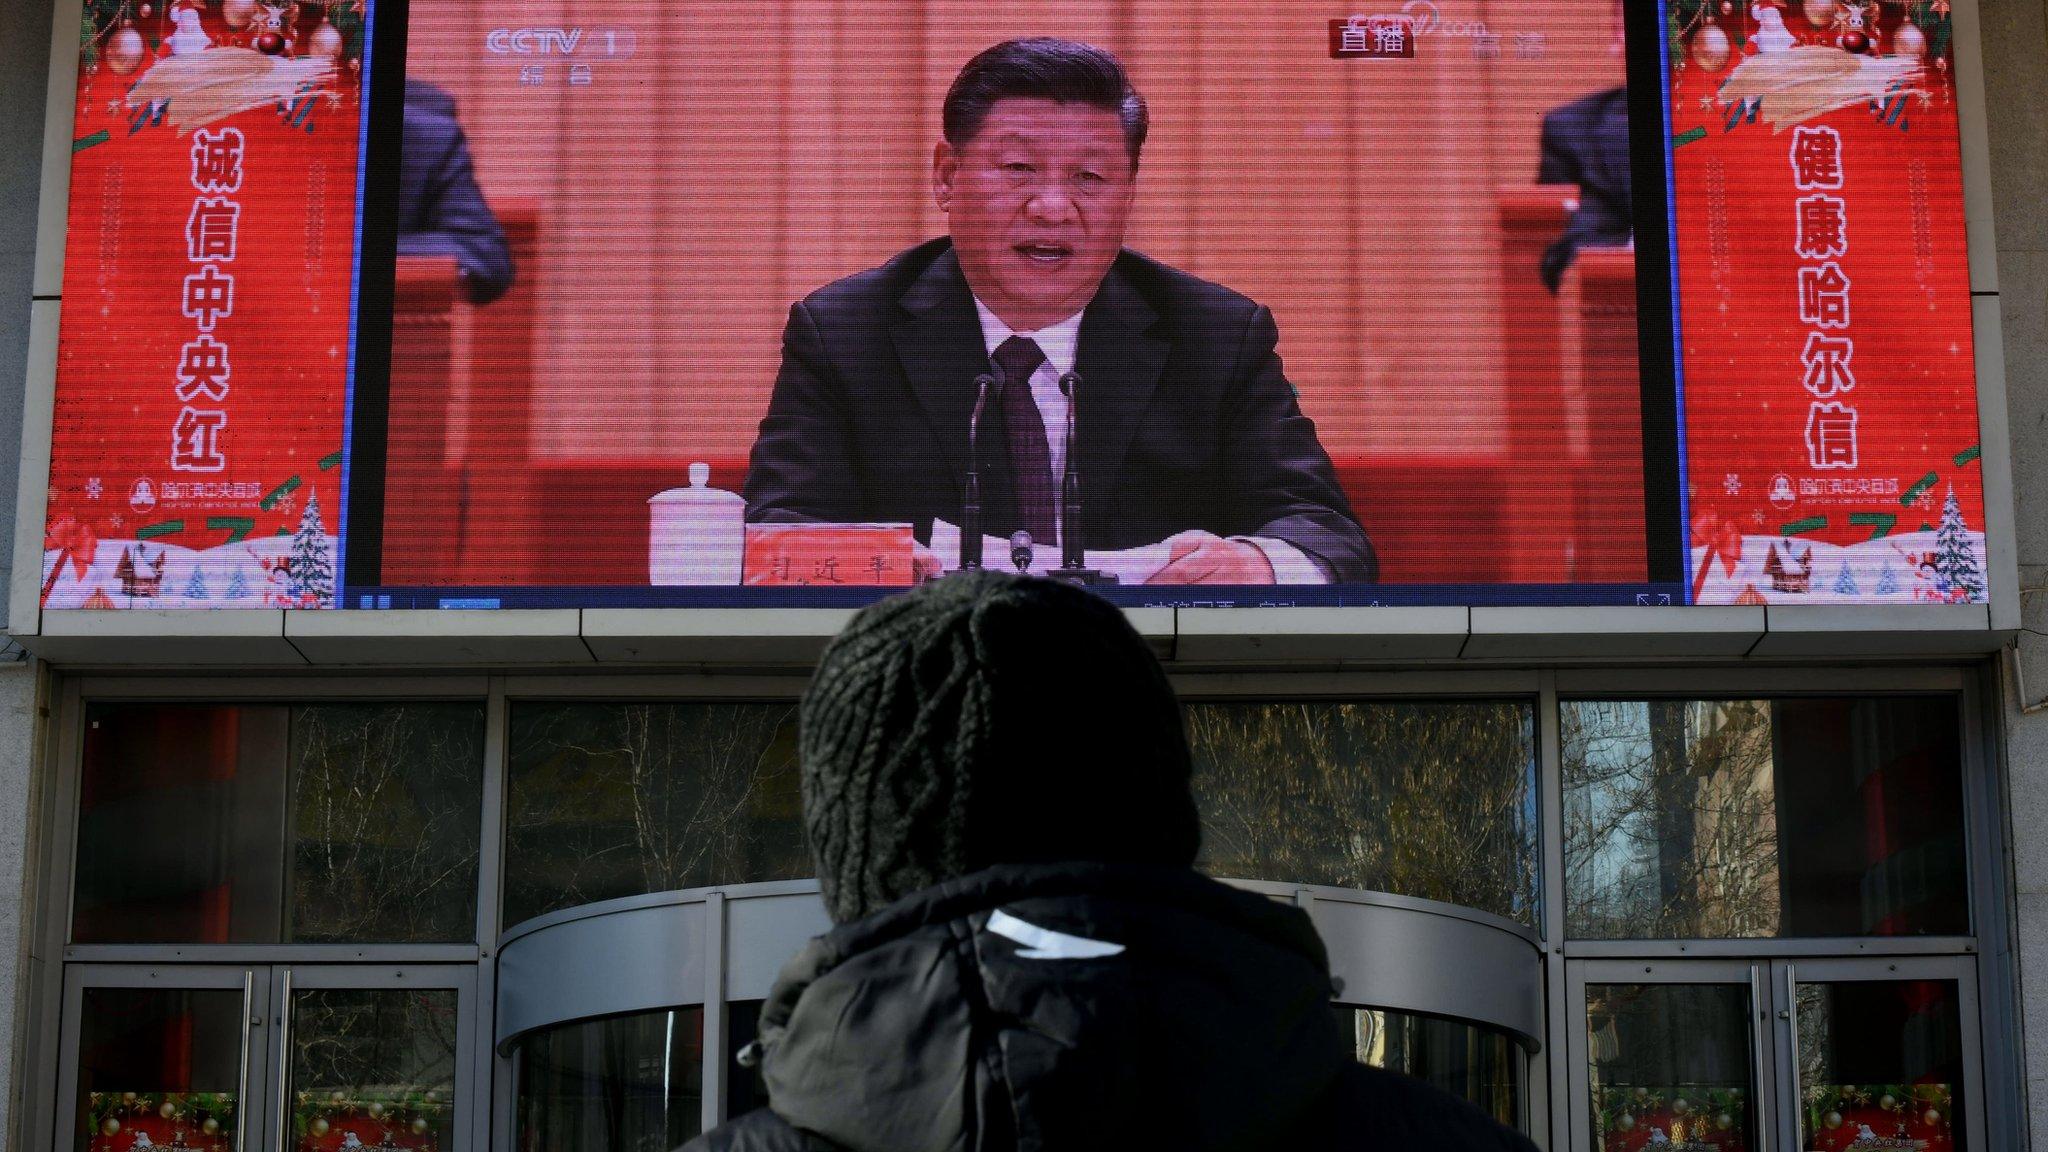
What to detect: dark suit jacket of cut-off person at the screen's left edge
<box><xmin>397</xmin><ymin>80</ymin><xmax>512</xmax><ymax>303</ymax></box>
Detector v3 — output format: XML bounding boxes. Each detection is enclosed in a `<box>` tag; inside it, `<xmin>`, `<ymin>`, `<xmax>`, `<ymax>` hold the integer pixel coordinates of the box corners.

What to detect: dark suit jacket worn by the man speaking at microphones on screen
<box><xmin>745</xmin><ymin>238</ymin><xmax>1378</xmax><ymax>582</ymax></box>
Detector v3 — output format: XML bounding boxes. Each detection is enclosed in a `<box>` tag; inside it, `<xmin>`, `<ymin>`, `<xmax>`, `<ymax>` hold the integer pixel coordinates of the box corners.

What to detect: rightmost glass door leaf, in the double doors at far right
<box><xmin>1772</xmin><ymin>957</ymin><xmax>1985</xmax><ymax>1152</ymax></box>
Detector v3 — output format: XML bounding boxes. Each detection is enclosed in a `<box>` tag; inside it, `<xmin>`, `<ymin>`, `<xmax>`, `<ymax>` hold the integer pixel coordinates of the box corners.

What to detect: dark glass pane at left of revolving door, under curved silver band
<box><xmin>512</xmin><ymin>1009</ymin><xmax>705</xmax><ymax>1152</ymax></box>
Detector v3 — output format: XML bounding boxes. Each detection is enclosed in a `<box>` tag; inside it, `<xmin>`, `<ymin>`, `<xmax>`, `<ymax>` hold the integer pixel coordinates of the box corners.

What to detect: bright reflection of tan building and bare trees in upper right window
<box><xmin>1559</xmin><ymin>701</ymin><xmax>1780</xmax><ymax>939</ymax></box>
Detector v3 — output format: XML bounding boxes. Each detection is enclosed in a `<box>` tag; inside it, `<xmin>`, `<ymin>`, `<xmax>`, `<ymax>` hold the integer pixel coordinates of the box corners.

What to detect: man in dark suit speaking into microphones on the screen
<box><xmin>745</xmin><ymin>39</ymin><xmax>1378</xmax><ymax>584</ymax></box>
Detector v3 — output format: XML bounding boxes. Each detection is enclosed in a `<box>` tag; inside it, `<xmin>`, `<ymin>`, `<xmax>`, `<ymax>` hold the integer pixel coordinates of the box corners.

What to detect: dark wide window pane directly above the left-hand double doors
<box><xmin>72</xmin><ymin>703</ymin><xmax>483</xmax><ymax>943</ymax></box>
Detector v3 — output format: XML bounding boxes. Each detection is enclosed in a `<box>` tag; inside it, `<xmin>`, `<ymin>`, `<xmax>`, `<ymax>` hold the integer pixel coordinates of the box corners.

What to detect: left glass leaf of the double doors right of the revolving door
<box><xmin>1567</xmin><ymin>959</ymin><xmax>1774</xmax><ymax>1152</ymax></box>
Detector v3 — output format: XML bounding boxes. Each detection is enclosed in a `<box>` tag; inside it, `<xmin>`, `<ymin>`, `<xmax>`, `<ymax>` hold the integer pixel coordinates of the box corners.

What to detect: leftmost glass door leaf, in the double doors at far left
<box><xmin>55</xmin><ymin>965</ymin><xmax>270</xmax><ymax>1152</ymax></box>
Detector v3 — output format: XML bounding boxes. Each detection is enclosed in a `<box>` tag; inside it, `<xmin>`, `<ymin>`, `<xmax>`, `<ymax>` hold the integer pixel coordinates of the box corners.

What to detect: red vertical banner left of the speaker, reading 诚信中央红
<box><xmin>43</xmin><ymin>0</ymin><xmax>369</xmax><ymax>609</ymax></box>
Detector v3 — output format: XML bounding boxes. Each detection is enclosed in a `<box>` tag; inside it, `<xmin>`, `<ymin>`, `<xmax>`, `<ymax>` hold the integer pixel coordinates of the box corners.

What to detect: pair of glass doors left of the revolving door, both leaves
<box><xmin>55</xmin><ymin>965</ymin><xmax>483</xmax><ymax>1152</ymax></box>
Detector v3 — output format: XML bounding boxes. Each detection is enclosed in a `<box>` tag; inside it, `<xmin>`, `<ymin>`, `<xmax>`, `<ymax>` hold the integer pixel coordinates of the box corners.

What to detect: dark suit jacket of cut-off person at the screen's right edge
<box><xmin>1536</xmin><ymin>88</ymin><xmax>1636</xmax><ymax>291</ymax></box>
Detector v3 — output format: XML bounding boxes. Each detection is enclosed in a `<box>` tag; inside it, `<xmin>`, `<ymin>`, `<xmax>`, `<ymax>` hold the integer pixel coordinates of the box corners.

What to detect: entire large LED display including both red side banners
<box><xmin>43</xmin><ymin>0</ymin><xmax>1987</xmax><ymax>609</ymax></box>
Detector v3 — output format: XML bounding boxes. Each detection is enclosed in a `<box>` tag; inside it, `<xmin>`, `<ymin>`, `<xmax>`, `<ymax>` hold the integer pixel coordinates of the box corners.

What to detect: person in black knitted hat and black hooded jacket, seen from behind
<box><xmin>684</xmin><ymin>572</ymin><xmax>1534</xmax><ymax>1152</ymax></box>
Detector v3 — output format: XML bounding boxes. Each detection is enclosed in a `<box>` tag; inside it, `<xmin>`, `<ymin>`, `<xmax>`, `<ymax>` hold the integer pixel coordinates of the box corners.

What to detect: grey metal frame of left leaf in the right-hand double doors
<box><xmin>1552</xmin><ymin>959</ymin><xmax>1780</xmax><ymax>1152</ymax></box>
